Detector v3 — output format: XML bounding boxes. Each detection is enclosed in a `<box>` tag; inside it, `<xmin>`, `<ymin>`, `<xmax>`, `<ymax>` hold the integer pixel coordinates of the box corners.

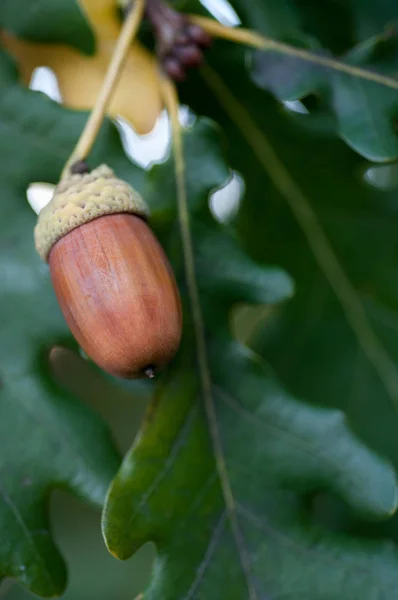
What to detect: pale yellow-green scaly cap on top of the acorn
<box><xmin>35</xmin><ymin>165</ymin><xmax>149</xmax><ymax>261</ymax></box>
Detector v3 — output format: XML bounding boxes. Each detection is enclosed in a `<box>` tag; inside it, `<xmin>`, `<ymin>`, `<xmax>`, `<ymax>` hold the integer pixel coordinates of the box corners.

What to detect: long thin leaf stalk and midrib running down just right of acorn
<box><xmin>161</xmin><ymin>76</ymin><xmax>258</xmax><ymax>600</ymax></box>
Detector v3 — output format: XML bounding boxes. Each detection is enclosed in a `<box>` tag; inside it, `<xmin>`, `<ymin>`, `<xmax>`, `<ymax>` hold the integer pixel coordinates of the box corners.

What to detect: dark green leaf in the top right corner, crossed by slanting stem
<box><xmin>219</xmin><ymin>0</ymin><xmax>398</xmax><ymax>161</ymax></box>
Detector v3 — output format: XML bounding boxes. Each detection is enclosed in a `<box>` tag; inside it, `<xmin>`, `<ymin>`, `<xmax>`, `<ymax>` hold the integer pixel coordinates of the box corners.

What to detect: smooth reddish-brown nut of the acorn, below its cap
<box><xmin>49</xmin><ymin>214</ymin><xmax>182</xmax><ymax>378</ymax></box>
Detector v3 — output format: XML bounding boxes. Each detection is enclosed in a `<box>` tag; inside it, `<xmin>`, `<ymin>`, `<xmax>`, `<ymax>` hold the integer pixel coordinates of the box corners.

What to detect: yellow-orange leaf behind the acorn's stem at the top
<box><xmin>1</xmin><ymin>0</ymin><xmax>162</xmax><ymax>133</ymax></box>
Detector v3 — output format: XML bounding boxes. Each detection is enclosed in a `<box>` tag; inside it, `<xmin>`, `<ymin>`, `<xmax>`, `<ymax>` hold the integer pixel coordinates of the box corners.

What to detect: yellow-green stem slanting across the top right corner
<box><xmin>189</xmin><ymin>15</ymin><xmax>398</xmax><ymax>90</ymax></box>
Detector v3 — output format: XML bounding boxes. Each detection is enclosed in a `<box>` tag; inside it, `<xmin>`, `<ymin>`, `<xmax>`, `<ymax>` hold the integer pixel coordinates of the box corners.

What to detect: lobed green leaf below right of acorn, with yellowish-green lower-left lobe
<box><xmin>103</xmin><ymin>120</ymin><xmax>398</xmax><ymax>600</ymax></box>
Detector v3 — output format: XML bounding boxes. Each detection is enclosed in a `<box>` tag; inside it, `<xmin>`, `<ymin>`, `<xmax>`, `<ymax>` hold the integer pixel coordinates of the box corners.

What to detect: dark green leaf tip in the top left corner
<box><xmin>0</xmin><ymin>0</ymin><xmax>95</xmax><ymax>54</ymax></box>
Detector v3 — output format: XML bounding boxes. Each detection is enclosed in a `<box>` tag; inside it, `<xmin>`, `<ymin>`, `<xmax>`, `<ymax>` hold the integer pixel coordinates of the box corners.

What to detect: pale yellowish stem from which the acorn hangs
<box><xmin>62</xmin><ymin>0</ymin><xmax>145</xmax><ymax>177</ymax></box>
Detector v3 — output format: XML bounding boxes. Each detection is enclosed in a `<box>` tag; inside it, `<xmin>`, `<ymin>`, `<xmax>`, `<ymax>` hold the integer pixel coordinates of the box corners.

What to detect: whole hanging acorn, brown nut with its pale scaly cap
<box><xmin>35</xmin><ymin>165</ymin><xmax>182</xmax><ymax>379</ymax></box>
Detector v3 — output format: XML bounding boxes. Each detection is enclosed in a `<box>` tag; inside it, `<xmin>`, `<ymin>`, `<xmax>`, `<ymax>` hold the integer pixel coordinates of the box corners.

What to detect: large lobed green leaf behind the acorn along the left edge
<box><xmin>0</xmin><ymin>53</ymin><xmax>145</xmax><ymax>596</ymax></box>
